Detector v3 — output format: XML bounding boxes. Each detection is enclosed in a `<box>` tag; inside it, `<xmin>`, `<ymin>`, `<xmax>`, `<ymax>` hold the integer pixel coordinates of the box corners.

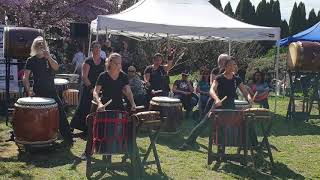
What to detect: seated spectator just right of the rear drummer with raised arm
<box><xmin>172</xmin><ymin>71</ymin><xmax>193</xmax><ymax>117</ymax></box>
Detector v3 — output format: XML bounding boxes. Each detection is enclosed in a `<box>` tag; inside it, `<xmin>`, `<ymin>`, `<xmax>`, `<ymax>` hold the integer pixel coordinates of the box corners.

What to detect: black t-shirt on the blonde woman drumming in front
<box><xmin>97</xmin><ymin>72</ymin><xmax>129</xmax><ymax>110</ymax></box>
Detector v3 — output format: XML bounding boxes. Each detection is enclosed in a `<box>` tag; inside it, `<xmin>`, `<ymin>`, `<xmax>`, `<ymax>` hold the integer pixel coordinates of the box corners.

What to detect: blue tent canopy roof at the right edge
<box><xmin>279</xmin><ymin>22</ymin><xmax>320</xmax><ymax>46</ymax></box>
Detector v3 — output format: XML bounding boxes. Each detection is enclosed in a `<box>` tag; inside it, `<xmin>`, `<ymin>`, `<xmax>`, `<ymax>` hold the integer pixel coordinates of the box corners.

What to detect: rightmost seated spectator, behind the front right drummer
<box><xmin>249</xmin><ymin>71</ymin><xmax>269</xmax><ymax>109</ymax></box>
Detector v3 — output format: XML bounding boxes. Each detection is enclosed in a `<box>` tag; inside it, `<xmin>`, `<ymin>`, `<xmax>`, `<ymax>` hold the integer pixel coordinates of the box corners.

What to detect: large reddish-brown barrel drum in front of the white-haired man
<box><xmin>13</xmin><ymin>97</ymin><xmax>59</xmax><ymax>145</ymax></box>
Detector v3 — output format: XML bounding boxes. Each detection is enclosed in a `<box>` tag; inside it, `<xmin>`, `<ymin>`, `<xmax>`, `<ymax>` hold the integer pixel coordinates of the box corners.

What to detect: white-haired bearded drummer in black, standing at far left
<box><xmin>23</xmin><ymin>36</ymin><xmax>73</xmax><ymax>145</ymax></box>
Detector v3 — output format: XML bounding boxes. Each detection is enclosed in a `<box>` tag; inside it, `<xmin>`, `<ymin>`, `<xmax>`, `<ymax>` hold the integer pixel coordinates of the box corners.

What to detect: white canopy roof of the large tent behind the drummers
<box><xmin>91</xmin><ymin>0</ymin><xmax>280</xmax><ymax>41</ymax></box>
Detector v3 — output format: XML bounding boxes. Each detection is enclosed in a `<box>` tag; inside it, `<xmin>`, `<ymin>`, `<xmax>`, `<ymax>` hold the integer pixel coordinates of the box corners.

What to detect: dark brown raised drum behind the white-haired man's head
<box><xmin>4</xmin><ymin>27</ymin><xmax>43</xmax><ymax>59</ymax></box>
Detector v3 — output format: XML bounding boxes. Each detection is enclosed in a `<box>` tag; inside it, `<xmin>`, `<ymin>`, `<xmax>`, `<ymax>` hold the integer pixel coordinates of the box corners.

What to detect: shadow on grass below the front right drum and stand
<box><xmin>221</xmin><ymin>162</ymin><xmax>305</xmax><ymax>179</ymax></box>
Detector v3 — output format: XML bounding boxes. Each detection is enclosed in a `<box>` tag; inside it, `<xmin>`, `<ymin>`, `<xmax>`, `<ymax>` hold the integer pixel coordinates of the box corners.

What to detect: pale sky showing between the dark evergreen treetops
<box><xmin>221</xmin><ymin>0</ymin><xmax>320</xmax><ymax>21</ymax></box>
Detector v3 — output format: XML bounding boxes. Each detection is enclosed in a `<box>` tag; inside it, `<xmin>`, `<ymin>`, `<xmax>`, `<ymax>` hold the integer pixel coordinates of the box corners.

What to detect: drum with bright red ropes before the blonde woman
<box><xmin>92</xmin><ymin>111</ymin><xmax>132</xmax><ymax>154</ymax></box>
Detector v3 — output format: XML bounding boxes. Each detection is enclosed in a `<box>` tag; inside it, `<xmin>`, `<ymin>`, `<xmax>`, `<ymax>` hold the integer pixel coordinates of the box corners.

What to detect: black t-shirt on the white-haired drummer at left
<box><xmin>26</xmin><ymin>56</ymin><xmax>56</xmax><ymax>96</ymax></box>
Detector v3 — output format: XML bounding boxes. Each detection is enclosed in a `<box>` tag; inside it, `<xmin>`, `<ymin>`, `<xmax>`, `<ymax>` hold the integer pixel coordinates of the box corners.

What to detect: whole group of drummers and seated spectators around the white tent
<box><xmin>23</xmin><ymin>37</ymin><xmax>269</xmax><ymax>155</ymax></box>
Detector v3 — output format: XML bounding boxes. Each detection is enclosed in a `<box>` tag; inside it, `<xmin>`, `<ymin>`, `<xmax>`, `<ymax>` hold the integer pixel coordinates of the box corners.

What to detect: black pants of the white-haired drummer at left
<box><xmin>35</xmin><ymin>92</ymin><xmax>72</xmax><ymax>142</ymax></box>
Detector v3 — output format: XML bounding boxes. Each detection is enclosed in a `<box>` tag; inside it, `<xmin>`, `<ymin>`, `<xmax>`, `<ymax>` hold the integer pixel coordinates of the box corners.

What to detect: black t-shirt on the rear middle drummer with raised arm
<box><xmin>144</xmin><ymin>65</ymin><xmax>170</xmax><ymax>91</ymax></box>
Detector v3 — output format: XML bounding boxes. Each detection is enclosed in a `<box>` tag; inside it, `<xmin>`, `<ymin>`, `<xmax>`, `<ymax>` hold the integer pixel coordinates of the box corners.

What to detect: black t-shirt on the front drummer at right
<box><xmin>216</xmin><ymin>74</ymin><xmax>242</xmax><ymax>109</ymax></box>
